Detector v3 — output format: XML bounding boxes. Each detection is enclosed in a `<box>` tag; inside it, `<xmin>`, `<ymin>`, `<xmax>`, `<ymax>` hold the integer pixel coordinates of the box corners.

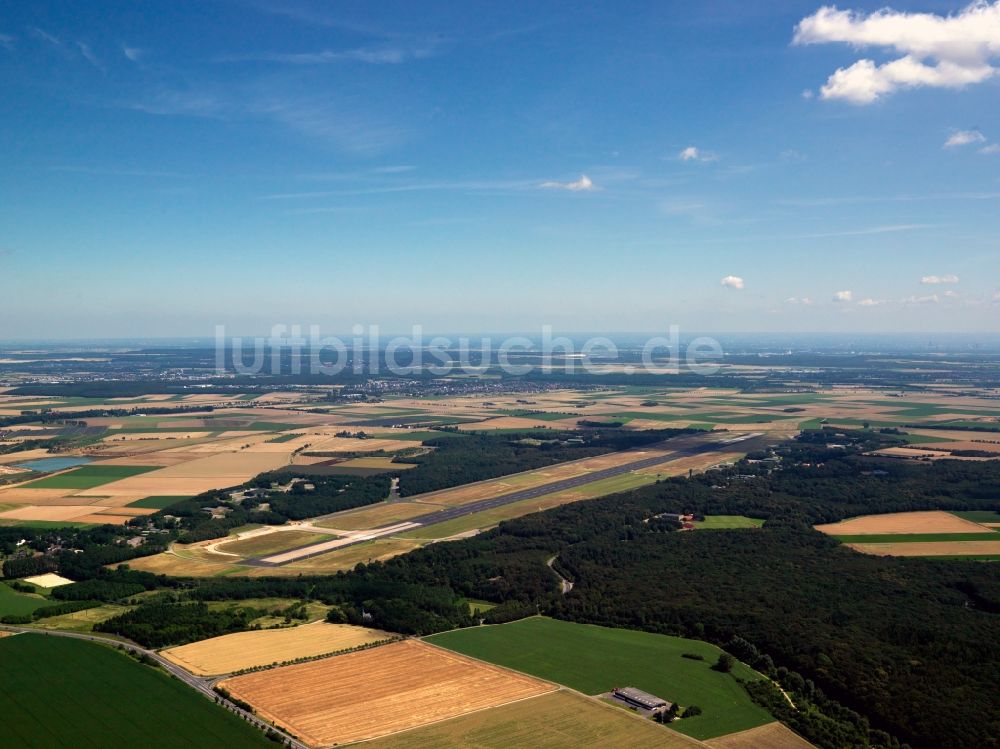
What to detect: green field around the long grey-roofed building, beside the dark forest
<box><xmin>427</xmin><ymin>617</ymin><xmax>774</xmax><ymax>739</ymax></box>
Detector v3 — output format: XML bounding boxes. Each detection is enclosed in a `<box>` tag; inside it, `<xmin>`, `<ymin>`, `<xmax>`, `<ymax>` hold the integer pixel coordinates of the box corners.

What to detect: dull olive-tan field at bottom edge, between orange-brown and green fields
<box><xmin>365</xmin><ymin>691</ymin><xmax>704</xmax><ymax>749</ymax></box>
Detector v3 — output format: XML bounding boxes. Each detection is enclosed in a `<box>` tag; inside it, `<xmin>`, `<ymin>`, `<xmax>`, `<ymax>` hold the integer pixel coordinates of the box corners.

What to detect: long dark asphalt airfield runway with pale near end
<box><xmin>246</xmin><ymin>433</ymin><xmax>760</xmax><ymax>567</ymax></box>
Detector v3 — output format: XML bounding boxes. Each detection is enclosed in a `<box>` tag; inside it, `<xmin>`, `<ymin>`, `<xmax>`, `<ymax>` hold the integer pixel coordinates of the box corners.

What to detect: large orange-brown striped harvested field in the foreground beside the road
<box><xmin>220</xmin><ymin>640</ymin><xmax>557</xmax><ymax>746</ymax></box>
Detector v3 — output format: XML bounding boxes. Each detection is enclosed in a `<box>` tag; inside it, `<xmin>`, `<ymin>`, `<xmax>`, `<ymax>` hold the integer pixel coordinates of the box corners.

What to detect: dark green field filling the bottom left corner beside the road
<box><xmin>0</xmin><ymin>634</ymin><xmax>275</xmax><ymax>749</ymax></box>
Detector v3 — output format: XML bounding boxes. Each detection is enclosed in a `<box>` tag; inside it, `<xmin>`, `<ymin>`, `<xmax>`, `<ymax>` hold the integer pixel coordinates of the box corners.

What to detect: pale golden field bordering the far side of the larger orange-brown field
<box><xmin>161</xmin><ymin>622</ymin><xmax>393</xmax><ymax>676</ymax></box>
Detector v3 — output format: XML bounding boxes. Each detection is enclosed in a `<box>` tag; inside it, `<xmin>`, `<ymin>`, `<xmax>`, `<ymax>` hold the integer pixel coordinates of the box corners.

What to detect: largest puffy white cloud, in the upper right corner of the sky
<box><xmin>792</xmin><ymin>0</ymin><xmax>1000</xmax><ymax>104</ymax></box>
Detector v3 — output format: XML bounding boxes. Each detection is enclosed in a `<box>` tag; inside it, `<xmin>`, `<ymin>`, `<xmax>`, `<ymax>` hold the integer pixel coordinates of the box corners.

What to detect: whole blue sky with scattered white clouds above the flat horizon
<box><xmin>0</xmin><ymin>0</ymin><xmax>1000</xmax><ymax>339</ymax></box>
